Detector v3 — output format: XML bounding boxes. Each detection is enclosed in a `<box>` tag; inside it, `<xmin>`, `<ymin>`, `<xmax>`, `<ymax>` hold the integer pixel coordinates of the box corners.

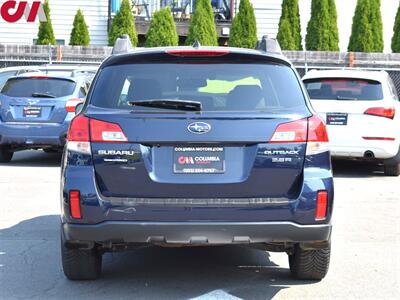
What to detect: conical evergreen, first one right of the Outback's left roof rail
<box><xmin>146</xmin><ymin>7</ymin><xmax>179</xmax><ymax>47</ymax></box>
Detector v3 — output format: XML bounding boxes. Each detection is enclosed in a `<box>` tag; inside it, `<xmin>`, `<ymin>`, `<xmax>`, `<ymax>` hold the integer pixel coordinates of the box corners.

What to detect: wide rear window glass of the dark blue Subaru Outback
<box><xmin>91</xmin><ymin>63</ymin><xmax>308</xmax><ymax>113</ymax></box>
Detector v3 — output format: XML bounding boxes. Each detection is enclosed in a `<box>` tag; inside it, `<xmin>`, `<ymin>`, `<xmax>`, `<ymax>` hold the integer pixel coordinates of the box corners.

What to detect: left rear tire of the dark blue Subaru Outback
<box><xmin>61</xmin><ymin>234</ymin><xmax>102</xmax><ymax>280</ymax></box>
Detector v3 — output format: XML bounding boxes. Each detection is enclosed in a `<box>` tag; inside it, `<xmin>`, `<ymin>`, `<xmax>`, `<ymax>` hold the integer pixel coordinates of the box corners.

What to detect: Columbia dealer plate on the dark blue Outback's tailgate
<box><xmin>174</xmin><ymin>146</ymin><xmax>225</xmax><ymax>174</ymax></box>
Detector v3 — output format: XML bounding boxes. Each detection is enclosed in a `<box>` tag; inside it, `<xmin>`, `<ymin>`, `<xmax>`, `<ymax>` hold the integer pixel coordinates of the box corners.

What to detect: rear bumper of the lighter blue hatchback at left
<box><xmin>0</xmin><ymin>122</ymin><xmax>69</xmax><ymax>148</ymax></box>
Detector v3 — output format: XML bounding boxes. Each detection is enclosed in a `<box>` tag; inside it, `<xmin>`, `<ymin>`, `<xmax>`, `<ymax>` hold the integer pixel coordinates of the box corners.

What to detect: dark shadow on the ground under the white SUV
<box><xmin>332</xmin><ymin>159</ymin><xmax>385</xmax><ymax>178</ymax></box>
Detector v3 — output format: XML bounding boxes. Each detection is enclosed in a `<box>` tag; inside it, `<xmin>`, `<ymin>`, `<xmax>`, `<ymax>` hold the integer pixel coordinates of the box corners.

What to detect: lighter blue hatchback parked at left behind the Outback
<box><xmin>0</xmin><ymin>73</ymin><xmax>90</xmax><ymax>163</ymax></box>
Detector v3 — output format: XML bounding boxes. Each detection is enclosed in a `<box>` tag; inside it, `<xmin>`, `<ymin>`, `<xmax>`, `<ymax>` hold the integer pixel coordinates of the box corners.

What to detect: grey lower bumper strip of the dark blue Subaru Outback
<box><xmin>62</xmin><ymin>221</ymin><xmax>332</xmax><ymax>245</ymax></box>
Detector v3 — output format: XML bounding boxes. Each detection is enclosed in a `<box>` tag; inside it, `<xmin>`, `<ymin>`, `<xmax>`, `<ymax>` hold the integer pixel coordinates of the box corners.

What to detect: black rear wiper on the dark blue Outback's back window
<box><xmin>128</xmin><ymin>99</ymin><xmax>202</xmax><ymax>111</ymax></box>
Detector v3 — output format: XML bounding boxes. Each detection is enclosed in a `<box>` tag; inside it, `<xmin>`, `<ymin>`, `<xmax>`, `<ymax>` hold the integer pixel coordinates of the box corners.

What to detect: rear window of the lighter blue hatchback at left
<box><xmin>1</xmin><ymin>77</ymin><xmax>76</xmax><ymax>98</ymax></box>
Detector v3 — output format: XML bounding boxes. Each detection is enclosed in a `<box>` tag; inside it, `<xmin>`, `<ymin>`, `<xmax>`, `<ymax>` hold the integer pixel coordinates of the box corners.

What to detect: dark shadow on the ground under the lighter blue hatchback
<box><xmin>0</xmin><ymin>150</ymin><xmax>62</xmax><ymax>167</ymax></box>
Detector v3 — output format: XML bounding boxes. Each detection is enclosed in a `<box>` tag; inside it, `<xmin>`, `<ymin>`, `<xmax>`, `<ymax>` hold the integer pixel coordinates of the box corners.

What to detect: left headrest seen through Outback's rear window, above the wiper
<box><xmin>127</xmin><ymin>78</ymin><xmax>162</xmax><ymax>101</ymax></box>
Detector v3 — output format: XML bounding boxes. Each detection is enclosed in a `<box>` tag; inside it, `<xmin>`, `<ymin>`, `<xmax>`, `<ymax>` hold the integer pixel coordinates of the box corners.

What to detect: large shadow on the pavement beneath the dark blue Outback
<box><xmin>0</xmin><ymin>215</ymin><xmax>315</xmax><ymax>299</ymax></box>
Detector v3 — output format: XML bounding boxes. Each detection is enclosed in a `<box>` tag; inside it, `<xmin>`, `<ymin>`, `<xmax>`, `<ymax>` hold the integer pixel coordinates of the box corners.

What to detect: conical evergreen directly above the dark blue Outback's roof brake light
<box><xmin>186</xmin><ymin>0</ymin><xmax>218</xmax><ymax>46</ymax></box>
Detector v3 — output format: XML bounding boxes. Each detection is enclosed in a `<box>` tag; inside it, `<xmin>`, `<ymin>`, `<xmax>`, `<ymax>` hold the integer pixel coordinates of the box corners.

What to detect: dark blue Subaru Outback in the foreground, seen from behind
<box><xmin>61</xmin><ymin>40</ymin><xmax>333</xmax><ymax>280</ymax></box>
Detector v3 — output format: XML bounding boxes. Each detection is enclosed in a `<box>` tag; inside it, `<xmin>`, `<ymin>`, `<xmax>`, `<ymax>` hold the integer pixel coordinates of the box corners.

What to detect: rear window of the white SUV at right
<box><xmin>304</xmin><ymin>78</ymin><xmax>383</xmax><ymax>101</ymax></box>
